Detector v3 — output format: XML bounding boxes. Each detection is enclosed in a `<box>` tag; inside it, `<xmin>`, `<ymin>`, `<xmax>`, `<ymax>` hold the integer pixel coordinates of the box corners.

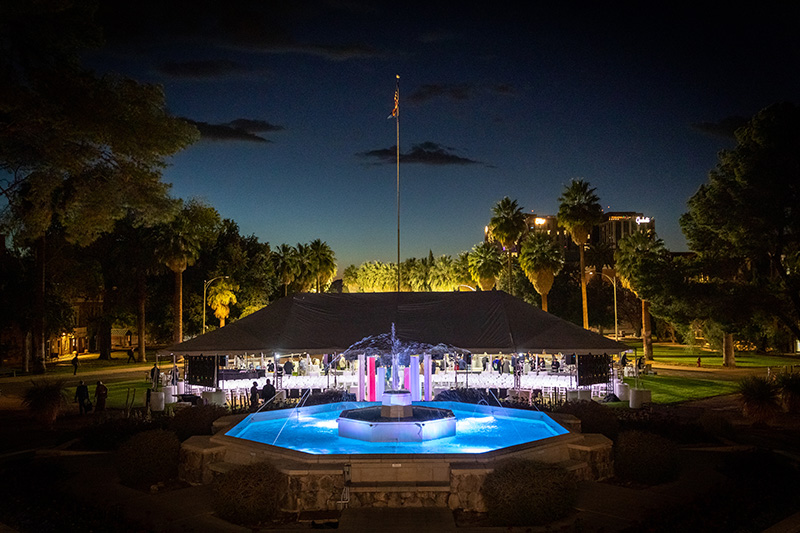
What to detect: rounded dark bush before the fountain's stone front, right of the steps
<box><xmin>481</xmin><ymin>459</ymin><xmax>577</xmax><ymax>526</ymax></box>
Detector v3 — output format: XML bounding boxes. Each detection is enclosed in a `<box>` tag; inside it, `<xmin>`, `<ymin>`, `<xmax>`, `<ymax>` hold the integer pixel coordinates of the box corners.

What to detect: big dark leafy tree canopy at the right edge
<box><xmin>681</xmin><ymin>103</ymin><xmax>800</xmax><ymax>338</ymax></box>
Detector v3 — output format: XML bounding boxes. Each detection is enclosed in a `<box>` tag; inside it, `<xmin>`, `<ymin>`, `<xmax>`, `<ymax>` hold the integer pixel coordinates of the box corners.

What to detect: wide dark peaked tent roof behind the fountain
<box><xmin>160</xmin><ymin>291</ymin><xmax>628</xmax><ymax>355</ymax></box>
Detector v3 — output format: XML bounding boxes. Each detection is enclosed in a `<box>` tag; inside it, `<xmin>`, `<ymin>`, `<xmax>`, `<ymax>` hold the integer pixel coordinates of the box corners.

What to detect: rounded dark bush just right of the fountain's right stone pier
<box><xmin>614</xmin><ymin>431</ymin><xmax>680</xmax><ymax>485</ymax></box>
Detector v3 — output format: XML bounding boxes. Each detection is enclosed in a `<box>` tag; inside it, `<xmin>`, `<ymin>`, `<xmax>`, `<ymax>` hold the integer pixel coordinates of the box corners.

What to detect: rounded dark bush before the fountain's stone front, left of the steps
<box><xmin>214</xmin><ymin>463</ymin><xmax>287</xmax><ymax>526</ymax></box>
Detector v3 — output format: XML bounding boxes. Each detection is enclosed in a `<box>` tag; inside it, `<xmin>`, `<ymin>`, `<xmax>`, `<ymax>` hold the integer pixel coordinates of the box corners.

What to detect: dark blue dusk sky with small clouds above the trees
<box><xmin>86</xmin><ymin>0</ymin><xmax>800</xmax><ymax>274</ymax></box>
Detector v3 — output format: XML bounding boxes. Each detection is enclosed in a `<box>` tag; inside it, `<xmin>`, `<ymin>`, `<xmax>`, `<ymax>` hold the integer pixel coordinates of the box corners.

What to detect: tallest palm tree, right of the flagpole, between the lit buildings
<box><xmin>558</xmin><ymin>179</ymin><xmax>603</xmax><ymax>329</ymax></box>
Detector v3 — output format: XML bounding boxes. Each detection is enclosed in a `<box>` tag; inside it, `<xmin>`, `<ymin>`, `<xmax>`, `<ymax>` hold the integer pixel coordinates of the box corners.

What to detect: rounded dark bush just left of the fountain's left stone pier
<box><xmin>117</xmin><ymin>429</ymin><xmax>181</xmax><ymax>487</ymax></box>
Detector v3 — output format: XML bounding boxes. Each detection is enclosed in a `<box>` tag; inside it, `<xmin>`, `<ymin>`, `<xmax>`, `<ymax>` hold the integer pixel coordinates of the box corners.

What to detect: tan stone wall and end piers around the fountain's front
<box><xmin>180</xmin><ymin>434</ymin><xmax>613</xmax><ymax>512</ymax></box>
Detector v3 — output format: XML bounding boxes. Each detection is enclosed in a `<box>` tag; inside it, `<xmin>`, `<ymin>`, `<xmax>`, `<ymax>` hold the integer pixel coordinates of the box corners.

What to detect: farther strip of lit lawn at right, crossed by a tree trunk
<box><xmin>625</xmin><ymin>339</ymin><xmax>800</xmax><ymax>368</ymax></box>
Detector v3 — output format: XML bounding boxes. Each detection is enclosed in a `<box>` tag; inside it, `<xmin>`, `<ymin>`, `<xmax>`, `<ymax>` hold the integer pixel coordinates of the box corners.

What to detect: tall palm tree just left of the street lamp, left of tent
<box><xmin>156</xmin><ymin>200</ymin><xmax>220</xmax><ymax>343</ymax></box>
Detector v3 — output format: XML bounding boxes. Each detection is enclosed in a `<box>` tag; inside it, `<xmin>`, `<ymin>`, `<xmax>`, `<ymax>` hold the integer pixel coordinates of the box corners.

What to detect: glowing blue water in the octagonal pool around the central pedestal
<box><xmin>226</xmin><ymin>402</ymin><xmax>568</xmax><ymax>454</ymax></box>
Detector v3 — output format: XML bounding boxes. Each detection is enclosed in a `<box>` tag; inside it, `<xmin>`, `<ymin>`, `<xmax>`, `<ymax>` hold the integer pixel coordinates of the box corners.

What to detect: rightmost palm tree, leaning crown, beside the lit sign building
<box><xmin>615</xmin><ymin>231</ymin><xmax>669</xmax><ymax>361</ymax></box>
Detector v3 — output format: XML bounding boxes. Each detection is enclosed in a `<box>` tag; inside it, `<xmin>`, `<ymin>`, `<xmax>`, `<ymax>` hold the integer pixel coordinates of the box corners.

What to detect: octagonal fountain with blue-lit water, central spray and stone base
<box><xmin>182</xmin><ymin>328</ymin><xmax>611</xmax><ymax>512</ymax></box>
